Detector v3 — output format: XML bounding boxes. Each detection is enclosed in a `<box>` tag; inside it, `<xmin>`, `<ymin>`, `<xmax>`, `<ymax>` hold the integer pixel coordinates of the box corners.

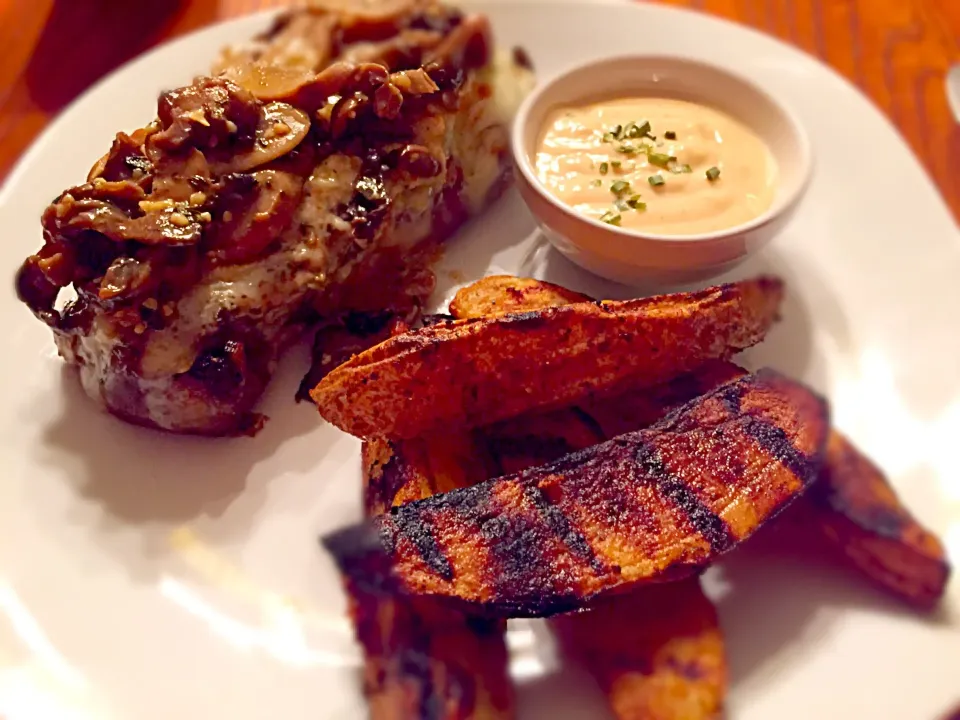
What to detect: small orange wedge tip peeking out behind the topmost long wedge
<box><xmin>450</xmin><ymin>275</ymin><xmax>593</xmax><ymax>320</ymax></box>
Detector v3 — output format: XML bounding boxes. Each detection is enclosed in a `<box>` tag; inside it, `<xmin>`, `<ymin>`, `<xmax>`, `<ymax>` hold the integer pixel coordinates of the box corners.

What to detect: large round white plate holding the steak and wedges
<box><xmin>0</xmin><ymin>3</ymin><xmax>960</xmax><ymax>720</ymax></box>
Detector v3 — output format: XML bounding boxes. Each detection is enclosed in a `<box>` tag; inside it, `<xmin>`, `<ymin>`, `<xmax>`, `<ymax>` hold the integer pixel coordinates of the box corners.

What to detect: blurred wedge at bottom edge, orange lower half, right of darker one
<box><xmin>551</xmin><ymin>578</ymin><xmax>727</xmax><ymax>720</ymax></box>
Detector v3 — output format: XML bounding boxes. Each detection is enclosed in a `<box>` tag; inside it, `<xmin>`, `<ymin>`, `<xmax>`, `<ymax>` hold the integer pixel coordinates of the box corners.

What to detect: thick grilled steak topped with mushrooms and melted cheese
<box><xmin>16</xmin><ymin>0</ymin><xmax>529</xmax><ymax>434</ymax></box>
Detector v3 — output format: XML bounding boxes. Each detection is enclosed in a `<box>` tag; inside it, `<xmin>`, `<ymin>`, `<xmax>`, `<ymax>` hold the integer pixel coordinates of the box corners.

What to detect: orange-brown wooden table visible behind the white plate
<box><xmin>0</xmin><ymin>0</ymin><xmax>960</xmax><ymax>221</ymax></box>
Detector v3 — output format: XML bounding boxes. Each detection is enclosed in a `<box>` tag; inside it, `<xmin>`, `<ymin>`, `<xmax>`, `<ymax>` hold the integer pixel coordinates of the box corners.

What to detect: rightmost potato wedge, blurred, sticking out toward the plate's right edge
<box><xmin>807</xmin><ymin>432</ymin><xmax>950</xmax><ymax>610</ymax></box>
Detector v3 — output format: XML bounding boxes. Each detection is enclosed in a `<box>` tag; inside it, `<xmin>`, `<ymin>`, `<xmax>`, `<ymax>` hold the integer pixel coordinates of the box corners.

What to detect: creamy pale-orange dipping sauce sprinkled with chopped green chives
<box><xmin>536</xmin><ymin>97</ymin><xmax>777</xmax><ymax>235</ymax></box>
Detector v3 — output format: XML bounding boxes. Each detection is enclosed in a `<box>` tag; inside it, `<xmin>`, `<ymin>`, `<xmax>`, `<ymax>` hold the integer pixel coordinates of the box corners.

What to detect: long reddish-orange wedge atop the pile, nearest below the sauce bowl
<box><xmin>311</xmin><ymin>277</ymin><xmax>783</xmax><ymax>439</ymax></box>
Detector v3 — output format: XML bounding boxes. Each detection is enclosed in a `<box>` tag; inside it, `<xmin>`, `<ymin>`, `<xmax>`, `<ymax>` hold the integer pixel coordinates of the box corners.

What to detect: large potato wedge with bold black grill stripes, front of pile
<box><xmin>325</xmin><ymin>372</ymin><xmax>828</xmax><ymax>617</ymax></box>
